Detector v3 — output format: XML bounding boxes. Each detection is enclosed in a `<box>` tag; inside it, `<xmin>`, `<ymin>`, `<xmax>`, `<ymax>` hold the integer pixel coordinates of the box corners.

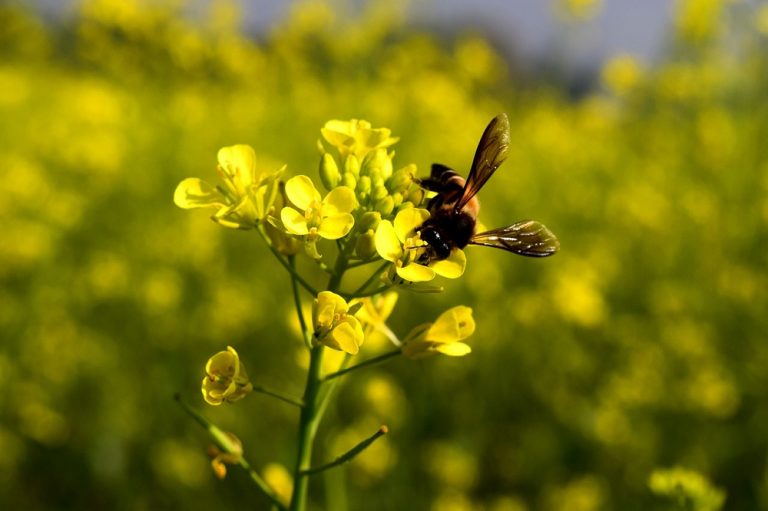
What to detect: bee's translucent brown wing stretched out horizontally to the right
<box><xmin>469</xmin><ymin>220</ymin><xmax>560</xmax><ymax>257</ymax></box>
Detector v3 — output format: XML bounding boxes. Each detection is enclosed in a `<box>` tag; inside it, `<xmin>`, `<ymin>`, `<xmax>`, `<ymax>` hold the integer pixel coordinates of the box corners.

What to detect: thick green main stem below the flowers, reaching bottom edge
<box><xmin>289</xmin><ymin>346</ymin><xmax>325</xmax><ymax>511</ymax></box>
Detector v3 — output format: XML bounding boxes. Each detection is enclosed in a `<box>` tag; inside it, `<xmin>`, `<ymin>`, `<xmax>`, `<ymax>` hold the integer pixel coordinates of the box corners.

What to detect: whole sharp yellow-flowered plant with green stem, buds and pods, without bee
<box><xmin>174</xmin><ymin>119</ymin><xmax>486</xmax><ymax>511</ymax></box>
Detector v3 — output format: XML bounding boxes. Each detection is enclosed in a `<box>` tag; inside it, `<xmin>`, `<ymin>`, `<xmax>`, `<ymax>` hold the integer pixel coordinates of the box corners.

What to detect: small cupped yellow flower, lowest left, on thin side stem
<box><xmin>201</xmin><ymin>346</ymin><xmax>253</xmax><ymax>405</ymax></box>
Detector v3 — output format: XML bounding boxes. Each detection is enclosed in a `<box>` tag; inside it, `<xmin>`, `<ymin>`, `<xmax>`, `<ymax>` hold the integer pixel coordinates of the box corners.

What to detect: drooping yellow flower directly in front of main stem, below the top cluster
<box><xmin>312</xmin><ymin>291</ymin><xmax>365</xmax><ymax>355</ymax></box>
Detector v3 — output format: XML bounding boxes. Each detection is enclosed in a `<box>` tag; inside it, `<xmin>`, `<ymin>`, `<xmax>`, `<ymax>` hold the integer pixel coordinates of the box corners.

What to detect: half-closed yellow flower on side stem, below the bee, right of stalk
<box><xmin>402</xmin><ymin>305</ymin><xmax>475</xmax><ymax>358</ymax></box>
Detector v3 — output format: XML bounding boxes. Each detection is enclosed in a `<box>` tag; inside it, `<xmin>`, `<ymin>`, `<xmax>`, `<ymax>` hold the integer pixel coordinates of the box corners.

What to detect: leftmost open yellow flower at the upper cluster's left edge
<box><xmin>173</xmin><ymin>144</ymin><xmax>285</xmax><ymax>229</ymax></box>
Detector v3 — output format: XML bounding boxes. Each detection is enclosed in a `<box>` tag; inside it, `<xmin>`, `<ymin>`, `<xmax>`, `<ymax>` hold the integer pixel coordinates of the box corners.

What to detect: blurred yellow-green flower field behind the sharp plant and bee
<box><xmin>0</xmin><ymin>0</ymin><xmax>768</xmax><ymax>511</ymax></box>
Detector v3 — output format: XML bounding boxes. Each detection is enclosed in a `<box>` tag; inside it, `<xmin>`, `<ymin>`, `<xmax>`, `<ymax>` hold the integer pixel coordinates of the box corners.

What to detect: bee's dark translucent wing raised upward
<box><xmin>454</xmin><ymin>114</ymin><xmax>510</xmax><ymax>211</ymax></box>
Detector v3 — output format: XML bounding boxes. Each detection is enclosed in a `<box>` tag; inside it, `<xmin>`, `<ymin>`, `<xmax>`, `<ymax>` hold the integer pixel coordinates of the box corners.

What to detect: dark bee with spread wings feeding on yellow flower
<box><xmin>417</xmin><ymin>114</ymin><xmax>560</xmax><ymax>260</ymax></box>
